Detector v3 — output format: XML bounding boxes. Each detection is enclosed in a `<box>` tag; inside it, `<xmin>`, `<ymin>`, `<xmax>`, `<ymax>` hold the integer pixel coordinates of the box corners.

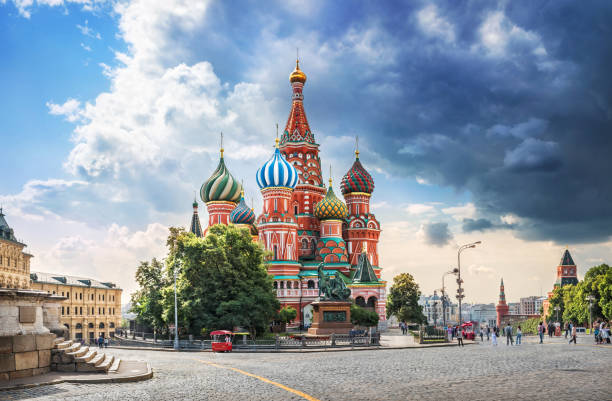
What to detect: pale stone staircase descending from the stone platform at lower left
<box><xmin>51</xmin><ymin>337</ymin><xmax>121</xmax><ymax>373</ymax></box>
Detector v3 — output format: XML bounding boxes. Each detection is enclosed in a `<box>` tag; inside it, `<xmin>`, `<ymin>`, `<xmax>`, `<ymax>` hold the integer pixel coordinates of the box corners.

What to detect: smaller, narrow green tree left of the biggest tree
<box><xmin>131</xmin><ymin>258</ymin><xmax>169</xmax><ymax>330</ymax></box>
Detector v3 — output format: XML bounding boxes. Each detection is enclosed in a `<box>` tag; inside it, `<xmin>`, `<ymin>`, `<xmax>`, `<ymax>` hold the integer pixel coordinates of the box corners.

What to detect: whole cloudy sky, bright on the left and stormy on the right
<box><xmin>0</xmin><ymin>0</ymin><xmax>612</xmax><ymax>303</ymax></box>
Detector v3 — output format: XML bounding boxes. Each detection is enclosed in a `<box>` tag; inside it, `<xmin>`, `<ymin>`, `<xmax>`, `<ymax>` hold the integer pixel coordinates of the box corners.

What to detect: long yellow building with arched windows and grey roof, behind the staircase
<box><xmin>30</xmin><ymin>272</ymin><xmax>122</xmax><ymax>341</ymax></box>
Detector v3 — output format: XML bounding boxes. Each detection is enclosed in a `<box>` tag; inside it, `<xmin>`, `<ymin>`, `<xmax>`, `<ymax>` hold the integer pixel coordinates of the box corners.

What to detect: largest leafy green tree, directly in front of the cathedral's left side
<box><xmin>170</xmin><ymin>225</ymin><xmax>280</xmax><ymax>336</ymax></box>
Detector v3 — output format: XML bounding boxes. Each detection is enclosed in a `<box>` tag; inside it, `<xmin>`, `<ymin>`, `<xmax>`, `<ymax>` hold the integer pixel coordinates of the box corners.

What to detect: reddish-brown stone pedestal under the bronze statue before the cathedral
<box><xmin>308</xmin><ymin>301</ymin><xmax>353</xmax><ymax>336</ymax></box>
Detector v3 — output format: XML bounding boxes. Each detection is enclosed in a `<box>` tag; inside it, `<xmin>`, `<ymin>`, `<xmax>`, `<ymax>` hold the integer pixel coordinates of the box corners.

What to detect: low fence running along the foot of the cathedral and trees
<box><xmin>110</xmin><ymin>333</ymin><xmax>380</xmax><ymax>352</ymax></box>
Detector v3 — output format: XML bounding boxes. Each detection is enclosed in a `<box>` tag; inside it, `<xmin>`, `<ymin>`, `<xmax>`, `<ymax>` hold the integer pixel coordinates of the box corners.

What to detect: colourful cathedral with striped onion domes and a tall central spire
<box><xmin>190</xmin><ymin>60</ymin><xmax>387</xmax><ymax>326</ymax></box>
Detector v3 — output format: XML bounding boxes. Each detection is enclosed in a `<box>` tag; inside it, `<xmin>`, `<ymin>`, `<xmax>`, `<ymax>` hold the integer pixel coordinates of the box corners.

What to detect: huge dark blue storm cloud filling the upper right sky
<box><xmin>292</xmin><ymin>1</ymin><xmax>612</xmax><ymax>243</ymax></box>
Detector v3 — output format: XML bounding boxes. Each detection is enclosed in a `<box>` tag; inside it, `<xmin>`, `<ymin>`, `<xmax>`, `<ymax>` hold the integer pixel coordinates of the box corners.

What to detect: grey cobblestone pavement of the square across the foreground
<box><xmin>0</xmin><ymin>337</ymin><xmax>612</xmax><ymax>401</ymax></box>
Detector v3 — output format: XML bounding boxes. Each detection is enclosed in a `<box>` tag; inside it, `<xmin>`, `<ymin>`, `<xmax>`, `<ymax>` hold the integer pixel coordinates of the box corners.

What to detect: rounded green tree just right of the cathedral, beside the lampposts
<box><xmin>387</xmin><ymin>273</ymin><xmax>427</xmax><ymax>324</ymax></box>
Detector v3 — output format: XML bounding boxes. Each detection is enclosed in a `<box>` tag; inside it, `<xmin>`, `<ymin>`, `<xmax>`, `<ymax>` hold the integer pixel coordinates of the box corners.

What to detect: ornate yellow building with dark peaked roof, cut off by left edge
<box><xmin>0</xmin><ymin>208</ymin><xmax>32</xmax><ymax>289</ymax></box>
